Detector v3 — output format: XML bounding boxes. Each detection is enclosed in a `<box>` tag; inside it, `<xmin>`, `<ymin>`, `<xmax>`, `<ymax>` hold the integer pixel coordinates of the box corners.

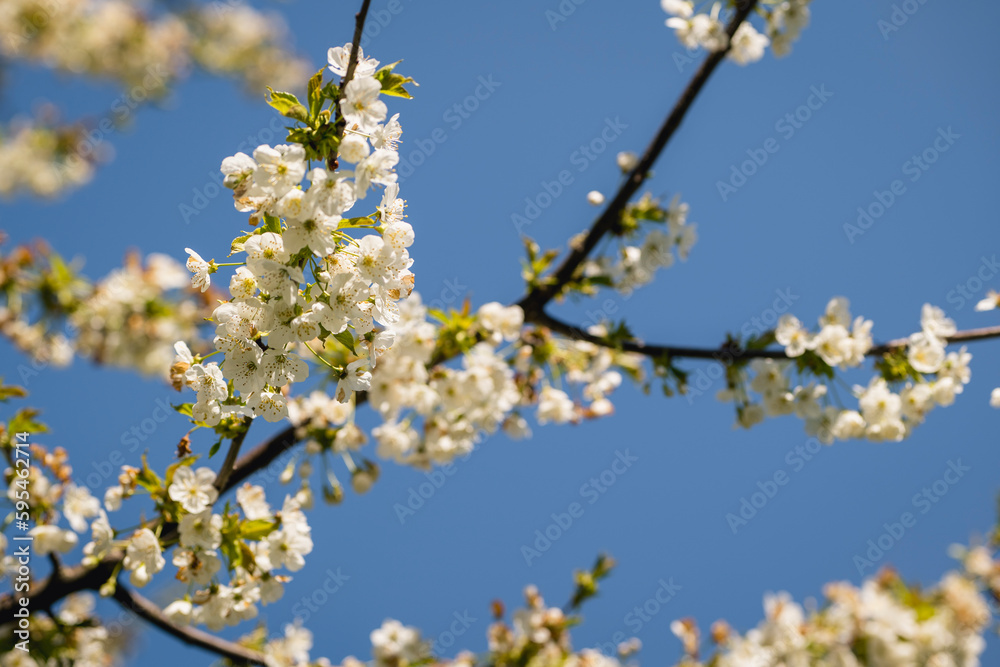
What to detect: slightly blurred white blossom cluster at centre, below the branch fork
<box><xmin>368</xmin><ymin>297</ymin><xmax>640</xmax><ymax>467</ymax></box>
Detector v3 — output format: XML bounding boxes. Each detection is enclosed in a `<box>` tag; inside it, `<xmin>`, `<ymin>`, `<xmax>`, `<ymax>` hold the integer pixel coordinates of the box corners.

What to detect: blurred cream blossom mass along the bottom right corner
<box><xmin>671</xmin><ymin>560</ymin><xmax>997</xmax><ymax>667</ymax></box>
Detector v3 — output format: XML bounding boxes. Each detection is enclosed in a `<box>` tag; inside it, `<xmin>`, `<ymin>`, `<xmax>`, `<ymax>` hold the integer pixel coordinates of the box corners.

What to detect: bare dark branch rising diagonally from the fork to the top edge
<box><xmin>517</xmin><ymin>0</ymin><xmax>757</xmax><ymax>319</ymax></box>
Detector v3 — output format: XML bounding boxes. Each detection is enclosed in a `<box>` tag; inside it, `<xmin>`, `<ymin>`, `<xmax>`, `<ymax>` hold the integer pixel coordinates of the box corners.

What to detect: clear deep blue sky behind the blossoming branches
<box><xmin>0</xmin><ymin>0</ymin><xmax>1000</xmax><ymax>665</ymax></box>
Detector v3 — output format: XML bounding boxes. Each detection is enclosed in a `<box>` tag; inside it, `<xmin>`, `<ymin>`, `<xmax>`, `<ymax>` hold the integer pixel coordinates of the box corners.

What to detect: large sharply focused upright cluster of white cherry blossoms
<box><xmin>173</xmin><ymin>44</ymin><xmax>414</xmax><ymax>426</ymax></box>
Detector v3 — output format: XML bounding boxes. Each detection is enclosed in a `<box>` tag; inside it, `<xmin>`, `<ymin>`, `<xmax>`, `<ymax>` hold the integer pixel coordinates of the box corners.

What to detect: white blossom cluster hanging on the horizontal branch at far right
<box><xmin>719</xmin><ymin>297</ymin><xmax>972</xmax><ymax>444</ymax></box>
